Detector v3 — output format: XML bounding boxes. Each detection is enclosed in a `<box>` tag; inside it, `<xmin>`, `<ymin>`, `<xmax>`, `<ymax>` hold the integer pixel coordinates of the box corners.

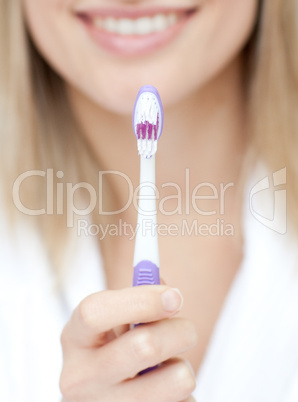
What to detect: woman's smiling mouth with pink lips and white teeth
<box><xmin>76</xmin><ymin>8</ymin><xmax>197</xmax><ymax>55</ymax></box>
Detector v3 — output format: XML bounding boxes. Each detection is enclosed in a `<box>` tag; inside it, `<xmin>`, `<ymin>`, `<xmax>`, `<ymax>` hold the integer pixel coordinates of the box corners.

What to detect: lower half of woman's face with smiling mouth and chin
<box><xmin>22</xmin><ymin>0</ymin><xmax>258</xmax><ymax>114</ymax></box>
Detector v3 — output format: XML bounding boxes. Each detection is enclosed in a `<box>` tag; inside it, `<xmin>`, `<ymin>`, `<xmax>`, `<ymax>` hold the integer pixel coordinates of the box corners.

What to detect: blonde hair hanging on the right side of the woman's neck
<box><xmin>247</xmin><ymin>0</ymin><xmax>298</xmax><ymax>223</ymax></box>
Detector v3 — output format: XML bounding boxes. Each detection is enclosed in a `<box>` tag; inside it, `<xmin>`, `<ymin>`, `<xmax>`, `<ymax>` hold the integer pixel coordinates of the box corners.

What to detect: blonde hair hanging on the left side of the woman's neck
<box><xmin>0</xmin><ymin>0</ymin><xmax>98</xmax><ymax>273</ymax></box>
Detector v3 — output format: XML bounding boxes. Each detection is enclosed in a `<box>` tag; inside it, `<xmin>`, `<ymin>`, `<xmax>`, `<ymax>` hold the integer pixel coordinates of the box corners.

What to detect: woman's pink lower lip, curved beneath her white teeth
<box><xmin>79</xmin><ymin>12</ymin><xmax>195</xmax><ymax>56</ymax></box>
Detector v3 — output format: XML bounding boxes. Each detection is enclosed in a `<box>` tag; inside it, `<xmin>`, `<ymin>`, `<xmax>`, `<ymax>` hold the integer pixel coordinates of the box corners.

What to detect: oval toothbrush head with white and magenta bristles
<box><xmin>133</xmin><ymin>85</ymin><xmax>163</xmax><ymax>158</ymax></box>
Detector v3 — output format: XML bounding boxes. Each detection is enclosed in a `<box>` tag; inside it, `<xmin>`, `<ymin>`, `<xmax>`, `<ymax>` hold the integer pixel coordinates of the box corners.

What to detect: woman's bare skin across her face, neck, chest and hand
<box><xmin>23</xmin><ymin>0</ymin><xmax>258</xmax><ymax>401</ymax></box>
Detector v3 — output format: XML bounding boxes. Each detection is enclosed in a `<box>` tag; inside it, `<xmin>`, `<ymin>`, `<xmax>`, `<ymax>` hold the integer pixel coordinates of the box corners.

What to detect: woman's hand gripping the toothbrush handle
<box><xmin>60</xmin><ymin>285</ymin><xmax>197</xmax><ymax>402</ymax></box>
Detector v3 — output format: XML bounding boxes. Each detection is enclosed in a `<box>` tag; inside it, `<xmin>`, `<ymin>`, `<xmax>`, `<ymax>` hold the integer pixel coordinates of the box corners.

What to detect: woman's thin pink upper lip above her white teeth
<box><xmin>75</xmin><ymin>6</ymin><xmax>197</xmax><ymax>19</ymax></box>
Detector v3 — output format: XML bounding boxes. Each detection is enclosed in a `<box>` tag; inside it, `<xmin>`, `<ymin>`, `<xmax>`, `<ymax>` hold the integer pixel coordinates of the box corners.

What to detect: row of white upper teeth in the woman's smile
<box><xmin>93</xmin><ymin>13</ymin><xmax>178</xmax><ymax>35</ymax></box>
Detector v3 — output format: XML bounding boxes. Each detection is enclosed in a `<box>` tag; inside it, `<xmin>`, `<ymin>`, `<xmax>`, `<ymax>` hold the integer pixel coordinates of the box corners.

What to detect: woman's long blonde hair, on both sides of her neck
<box><xmin>0</xmin><ymin>0</ymin><xmax>298</xmax><ymax>274</ymax></box>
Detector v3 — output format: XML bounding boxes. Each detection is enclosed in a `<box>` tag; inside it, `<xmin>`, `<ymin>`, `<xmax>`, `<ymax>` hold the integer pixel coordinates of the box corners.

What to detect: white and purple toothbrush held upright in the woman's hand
<box><xmin>131</xmin><ymin>85</ymin><xmax>163</xmax><ymax>374</ymax></box>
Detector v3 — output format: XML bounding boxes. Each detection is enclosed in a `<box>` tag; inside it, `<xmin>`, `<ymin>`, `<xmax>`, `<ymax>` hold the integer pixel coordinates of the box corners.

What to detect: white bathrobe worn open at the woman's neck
<box><xmin>0</xmin><ymin>165</ymin><xmax>298</xmax><ymax>402</ymax></box>
